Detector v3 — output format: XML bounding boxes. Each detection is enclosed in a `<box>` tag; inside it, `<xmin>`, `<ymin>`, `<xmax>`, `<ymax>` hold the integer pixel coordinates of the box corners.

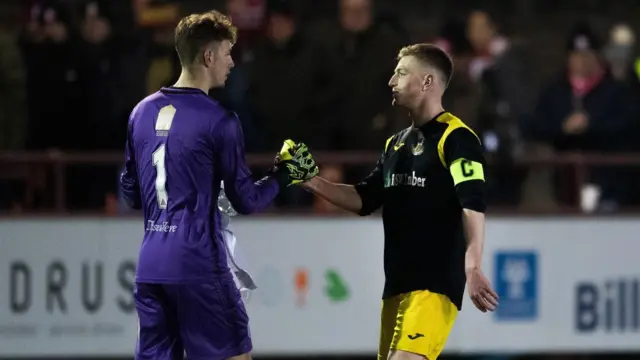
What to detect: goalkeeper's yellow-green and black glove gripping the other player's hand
<box><xmin>276</xmin><ymin>140</ymin><xmax>320</xmax><ymax>185</ymax></box>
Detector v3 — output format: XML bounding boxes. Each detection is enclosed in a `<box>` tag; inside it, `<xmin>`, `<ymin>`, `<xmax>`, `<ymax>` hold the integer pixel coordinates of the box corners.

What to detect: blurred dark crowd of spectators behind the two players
<box><xmin>0</xmin><ymin>0</ymin><xmax>640</xmax><ymax>212</ymax></box>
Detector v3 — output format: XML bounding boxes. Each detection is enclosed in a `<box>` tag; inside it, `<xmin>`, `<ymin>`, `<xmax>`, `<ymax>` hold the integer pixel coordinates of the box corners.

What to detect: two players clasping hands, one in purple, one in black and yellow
<box><xmin>120</xmin><ymin>11</ymin><xmax>497</xmax><ymax>360</ymax></box>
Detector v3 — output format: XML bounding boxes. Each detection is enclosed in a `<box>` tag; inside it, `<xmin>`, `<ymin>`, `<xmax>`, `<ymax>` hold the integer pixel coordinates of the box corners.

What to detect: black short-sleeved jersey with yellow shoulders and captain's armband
<box><xmin>356</xmin><ymin>112</ymin><xmax>485</xmax><ymax>308</ymax></box>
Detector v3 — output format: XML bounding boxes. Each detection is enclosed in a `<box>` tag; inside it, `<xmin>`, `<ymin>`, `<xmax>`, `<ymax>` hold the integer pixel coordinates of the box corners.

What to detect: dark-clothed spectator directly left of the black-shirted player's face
<box><xmin>331</xmin><ymin>0</ymin><xmax>408</xmax><ymax>151</ymax></box>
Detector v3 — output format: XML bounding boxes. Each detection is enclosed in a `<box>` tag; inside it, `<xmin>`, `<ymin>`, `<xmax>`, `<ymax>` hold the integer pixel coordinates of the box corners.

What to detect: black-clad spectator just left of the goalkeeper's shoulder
<box><xmin>77</xmin><ymin>0</ymin><xmax>149</xmax><ymax>143</ymax></box>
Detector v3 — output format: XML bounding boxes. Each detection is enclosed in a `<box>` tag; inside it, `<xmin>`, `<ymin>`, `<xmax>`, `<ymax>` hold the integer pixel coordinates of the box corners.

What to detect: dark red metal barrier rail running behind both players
<box><xmin>0</xmin><ymin>151</ymin><xmax>640</xmax><ymax>212</ymax></box>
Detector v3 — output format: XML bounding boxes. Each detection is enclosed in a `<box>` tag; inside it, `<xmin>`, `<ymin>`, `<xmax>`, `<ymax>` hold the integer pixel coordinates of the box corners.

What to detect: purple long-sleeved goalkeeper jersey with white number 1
<box><xmin>120</xmin><ymin>88</ymin><xmax>281</xmax><ymax>283</ymax></box>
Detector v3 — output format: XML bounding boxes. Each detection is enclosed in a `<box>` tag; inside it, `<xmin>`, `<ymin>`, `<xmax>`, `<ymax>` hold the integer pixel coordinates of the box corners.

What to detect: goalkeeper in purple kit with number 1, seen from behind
<box><xmin>120</xmin><ymin>11</ymin><xmax>318</xmax><ymax>360</ymax></box>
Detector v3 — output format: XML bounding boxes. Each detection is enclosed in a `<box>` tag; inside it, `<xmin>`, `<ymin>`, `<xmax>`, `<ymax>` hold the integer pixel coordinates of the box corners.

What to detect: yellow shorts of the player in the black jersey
<box><xmin>378</xmin><ymin>290</ymin><xmax>458</xmax><ymax>360</ymax></box>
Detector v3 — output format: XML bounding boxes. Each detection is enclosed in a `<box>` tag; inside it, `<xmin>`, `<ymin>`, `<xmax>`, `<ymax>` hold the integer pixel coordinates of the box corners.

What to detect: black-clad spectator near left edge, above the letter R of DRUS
<box><xmin>20</xmin><ymin>1</ymin><xmax>83</xmax><ymax>150</ymax></box>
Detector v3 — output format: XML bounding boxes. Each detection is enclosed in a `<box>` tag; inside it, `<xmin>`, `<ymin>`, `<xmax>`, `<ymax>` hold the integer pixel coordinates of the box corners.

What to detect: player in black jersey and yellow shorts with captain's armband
<box><xmin>303</xmin><ymin>44</ymin><xmax>498</xmax><ymax>360</ymax></box>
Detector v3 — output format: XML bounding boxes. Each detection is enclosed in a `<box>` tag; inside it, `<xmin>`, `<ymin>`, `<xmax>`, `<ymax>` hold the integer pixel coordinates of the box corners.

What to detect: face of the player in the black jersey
<box><xmin>389</xmin><ymin>56</ymin><xmax>428</xmax><ymax>108</ymax></box>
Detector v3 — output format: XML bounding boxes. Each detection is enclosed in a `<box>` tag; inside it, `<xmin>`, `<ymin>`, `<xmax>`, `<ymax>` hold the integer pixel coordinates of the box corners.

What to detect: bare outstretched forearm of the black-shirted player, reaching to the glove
<box><xmin>302</xmin><ymin>176</ymin><xmax>362</xmax><ymax>214</ymax></box>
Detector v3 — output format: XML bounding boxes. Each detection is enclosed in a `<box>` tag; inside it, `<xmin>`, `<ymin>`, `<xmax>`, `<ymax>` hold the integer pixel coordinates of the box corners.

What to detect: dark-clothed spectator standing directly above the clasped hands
<box><xmin>247</xmin><ymin>0</ymin><xmax>335</xmax><ymax>205</ymax></box>
